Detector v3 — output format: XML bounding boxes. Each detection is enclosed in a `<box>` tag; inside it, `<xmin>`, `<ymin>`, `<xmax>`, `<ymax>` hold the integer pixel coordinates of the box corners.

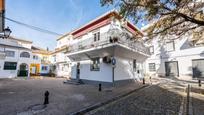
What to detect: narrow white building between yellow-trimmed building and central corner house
<box><xmin>51</xmin><ymin>35</ymin><xmax>71</xmax><ymax>77</ymax></box>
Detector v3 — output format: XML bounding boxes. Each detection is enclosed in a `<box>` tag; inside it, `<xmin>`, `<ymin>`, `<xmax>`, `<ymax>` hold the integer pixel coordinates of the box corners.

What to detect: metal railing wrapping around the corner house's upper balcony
<box><xmin>68</xmin><ymin>32</ymin><xmax>150</xmax><ymax>55</ymax></box>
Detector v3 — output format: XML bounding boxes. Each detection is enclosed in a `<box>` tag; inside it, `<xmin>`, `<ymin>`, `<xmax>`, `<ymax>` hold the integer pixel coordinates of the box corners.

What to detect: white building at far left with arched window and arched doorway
<box><xmin>0</xmin><ymin>37</ymin><xmax>32</xmax><ymax>78</ymax></box>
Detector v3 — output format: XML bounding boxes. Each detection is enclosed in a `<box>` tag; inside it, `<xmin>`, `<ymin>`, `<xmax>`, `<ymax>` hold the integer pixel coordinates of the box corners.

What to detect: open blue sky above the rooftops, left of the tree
<box><xmin>6</xmin><ymin>0</ymin><xmax>143</xmax><ymax>50</ymax></box>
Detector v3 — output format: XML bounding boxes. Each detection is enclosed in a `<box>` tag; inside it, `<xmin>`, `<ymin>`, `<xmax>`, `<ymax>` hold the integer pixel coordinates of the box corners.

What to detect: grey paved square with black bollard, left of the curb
<box><xmin>0</xmin><ymin>78</ymin><xmax>142</xmax><ymax>115</ymax></box>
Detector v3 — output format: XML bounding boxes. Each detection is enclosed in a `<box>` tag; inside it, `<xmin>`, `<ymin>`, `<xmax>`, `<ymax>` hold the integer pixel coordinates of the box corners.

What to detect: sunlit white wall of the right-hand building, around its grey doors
<box><xmin>145</xmin><ymin>36</ymin><xmax>204</xmax><ymax>79</ymax></box>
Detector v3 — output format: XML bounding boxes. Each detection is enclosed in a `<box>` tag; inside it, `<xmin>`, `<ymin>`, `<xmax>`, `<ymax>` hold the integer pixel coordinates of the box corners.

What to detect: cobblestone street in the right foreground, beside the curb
<box><xmin>87</xmin><ymin>80</ymin><xmax>185</xmax><ymax>115</ymax></box>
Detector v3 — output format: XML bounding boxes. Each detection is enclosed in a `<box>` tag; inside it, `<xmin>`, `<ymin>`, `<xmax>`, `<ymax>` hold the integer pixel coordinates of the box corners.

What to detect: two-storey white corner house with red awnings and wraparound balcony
<box><xmin>59</xmin><ymin>11</ymin><xmax>149</xmax><ymax>84</ymax></box>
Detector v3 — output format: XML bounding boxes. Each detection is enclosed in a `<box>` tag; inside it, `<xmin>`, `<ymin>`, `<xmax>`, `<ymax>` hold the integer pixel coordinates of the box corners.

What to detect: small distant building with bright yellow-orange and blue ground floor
<box><xmin>30</xmin><ymin>46</ymin><xmax>51</xmax><ymax>76</ymax></box>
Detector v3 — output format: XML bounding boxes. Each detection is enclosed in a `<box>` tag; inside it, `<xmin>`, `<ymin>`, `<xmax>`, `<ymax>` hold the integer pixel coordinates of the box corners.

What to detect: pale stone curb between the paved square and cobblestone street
<box><xmin>67</xmin><ymin>85</ymin><xmax>150</xmax><ymax>115</ymax></box>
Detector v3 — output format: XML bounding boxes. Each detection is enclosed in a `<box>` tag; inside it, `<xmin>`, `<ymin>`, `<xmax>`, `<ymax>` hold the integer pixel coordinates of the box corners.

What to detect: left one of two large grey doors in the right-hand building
<box><xmin>165</xmin><ymin>61</ymin><xmax>179</xmax><ymax>76</ymax></box>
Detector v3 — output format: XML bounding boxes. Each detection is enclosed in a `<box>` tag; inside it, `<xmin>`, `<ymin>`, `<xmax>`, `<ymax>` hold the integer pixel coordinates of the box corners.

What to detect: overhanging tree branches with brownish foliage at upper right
<box><xmin>101</xmin><ymin>0</ymin><xmax>204</xmax><ymax>39</ymax></box>
